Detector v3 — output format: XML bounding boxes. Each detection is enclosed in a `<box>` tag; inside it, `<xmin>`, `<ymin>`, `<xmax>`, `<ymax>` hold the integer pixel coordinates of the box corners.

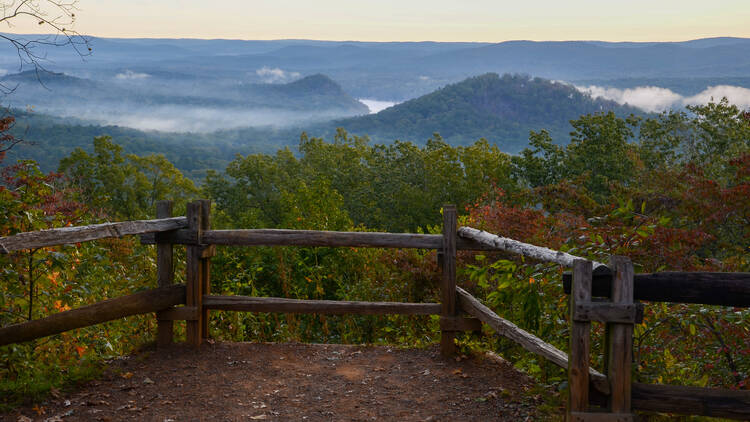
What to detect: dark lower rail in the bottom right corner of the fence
<box><xmin>633</xmin><ymin>383</ymin><xmax>750</xmax><ymax>421</ymax></box>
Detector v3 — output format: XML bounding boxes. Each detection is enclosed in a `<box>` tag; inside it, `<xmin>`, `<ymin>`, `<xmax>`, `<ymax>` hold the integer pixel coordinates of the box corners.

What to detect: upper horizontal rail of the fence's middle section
<box><xmin>141</xmin><ymin>229</ymin><xmax>492</xmax><ymax>250</ymax></box>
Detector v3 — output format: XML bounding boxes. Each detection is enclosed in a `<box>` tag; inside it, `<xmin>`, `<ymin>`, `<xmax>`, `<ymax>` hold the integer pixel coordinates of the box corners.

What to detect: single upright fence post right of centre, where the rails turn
<box><xmin>440</xmin><ymin>205</ymin><xmax>458</xmax><ymax>357</ymax></box>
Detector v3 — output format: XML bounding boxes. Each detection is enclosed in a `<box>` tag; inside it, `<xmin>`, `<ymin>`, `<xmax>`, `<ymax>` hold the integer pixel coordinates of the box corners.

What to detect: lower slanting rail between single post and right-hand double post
<box><xmin>456</xmin><ymin>287</ymin><xmax>609</xmax><ymax>394</ymax></box>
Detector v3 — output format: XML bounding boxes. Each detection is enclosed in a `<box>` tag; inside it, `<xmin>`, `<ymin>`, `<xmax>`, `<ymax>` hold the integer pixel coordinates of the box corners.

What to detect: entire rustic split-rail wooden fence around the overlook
<box><xmin>0</xmin><ymin>200</ymin><xmax>750</xmax><ymax>421</ymax></box>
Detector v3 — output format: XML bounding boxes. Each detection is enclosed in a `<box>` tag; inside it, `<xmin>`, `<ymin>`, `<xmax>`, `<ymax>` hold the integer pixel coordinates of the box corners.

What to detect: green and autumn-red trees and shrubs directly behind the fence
<box><xmin>0</xmin><ymin>99</ymin><xmax>750</xmax><ymax>404</ymax></box>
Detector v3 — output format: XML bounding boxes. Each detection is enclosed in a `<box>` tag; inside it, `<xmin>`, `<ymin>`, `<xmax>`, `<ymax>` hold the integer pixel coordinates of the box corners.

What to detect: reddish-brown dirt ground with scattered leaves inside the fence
<box><xmin>0</xmin><ymin>343</ymin><xmax>546</xmax><ymax>422</ymax></box>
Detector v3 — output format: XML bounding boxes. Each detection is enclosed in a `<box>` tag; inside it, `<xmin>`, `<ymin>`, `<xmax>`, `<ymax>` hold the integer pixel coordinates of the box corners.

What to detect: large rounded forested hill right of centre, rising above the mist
<box><xmin>332</xmin><ymin>73</ymin><xmax>643</xmax><ymax>153</ymax></box>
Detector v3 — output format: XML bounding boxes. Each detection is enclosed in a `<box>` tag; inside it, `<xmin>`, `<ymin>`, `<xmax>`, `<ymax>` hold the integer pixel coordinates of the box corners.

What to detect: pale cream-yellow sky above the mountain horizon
<box><xmin>0</xmin><ymin>0</ymin><xmax>750</xmax><ymax>42</ymax></box>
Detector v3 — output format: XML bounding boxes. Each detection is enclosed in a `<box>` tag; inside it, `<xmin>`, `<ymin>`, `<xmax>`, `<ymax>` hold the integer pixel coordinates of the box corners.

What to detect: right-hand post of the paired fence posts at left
<box><xmin>185</xmin><ymin>201</ymin><xmax>203</xmax><ymax>347</ymax></box>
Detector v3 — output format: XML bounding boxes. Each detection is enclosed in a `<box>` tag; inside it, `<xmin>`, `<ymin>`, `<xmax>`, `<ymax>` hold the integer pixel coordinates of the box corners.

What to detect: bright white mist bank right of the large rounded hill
<box><xmin>576</xmin><ymin>85</ymin><xmax>750</xmax><ymax>112</ymax></box>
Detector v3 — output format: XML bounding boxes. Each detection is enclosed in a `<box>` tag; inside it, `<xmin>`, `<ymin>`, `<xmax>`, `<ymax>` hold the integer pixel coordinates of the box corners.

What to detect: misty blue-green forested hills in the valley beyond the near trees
<box><xmin>9</xmin><ymin>74</ymin><xmax>644</xmax><ymax>176</ymax></box>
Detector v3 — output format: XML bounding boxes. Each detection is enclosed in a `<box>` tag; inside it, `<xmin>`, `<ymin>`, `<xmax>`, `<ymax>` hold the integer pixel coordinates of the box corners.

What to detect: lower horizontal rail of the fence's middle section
<box><xmin>203</xmin><ymin>296</ymin><xmax>440</xmax><ymax>315</ymax></box>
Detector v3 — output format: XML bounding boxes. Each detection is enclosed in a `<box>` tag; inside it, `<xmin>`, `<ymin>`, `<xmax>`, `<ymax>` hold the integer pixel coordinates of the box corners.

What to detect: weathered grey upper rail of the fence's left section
<box><xmin>0</xmin><ymin>217</ymin><xmax>187</xmax><ymax>253</ymax></box>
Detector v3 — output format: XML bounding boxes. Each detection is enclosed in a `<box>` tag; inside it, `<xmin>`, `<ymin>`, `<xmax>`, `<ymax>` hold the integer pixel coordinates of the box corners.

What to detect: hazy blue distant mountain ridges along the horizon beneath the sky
<box><xmin>0</xmin><ymin>37</ymin><xmax>750</xmax><ymax>101</ymax></box>
